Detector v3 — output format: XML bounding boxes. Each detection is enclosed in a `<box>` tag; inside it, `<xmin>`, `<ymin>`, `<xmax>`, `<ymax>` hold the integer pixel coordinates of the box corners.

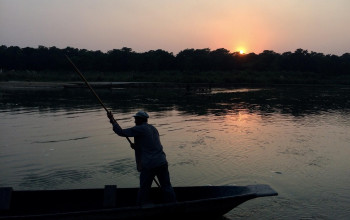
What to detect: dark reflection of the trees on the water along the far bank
<box><xmin>0</xmin><ymin>87</ymin><xmax>350</xmax><ymax>116</ymax></box>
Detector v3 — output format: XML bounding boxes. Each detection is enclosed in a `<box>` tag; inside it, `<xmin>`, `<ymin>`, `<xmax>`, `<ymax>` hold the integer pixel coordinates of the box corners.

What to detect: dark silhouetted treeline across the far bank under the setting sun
<box><xmin>0</xmin><ymin>45</ymin><xmax>350</xmax><ymax>83</ymax></box>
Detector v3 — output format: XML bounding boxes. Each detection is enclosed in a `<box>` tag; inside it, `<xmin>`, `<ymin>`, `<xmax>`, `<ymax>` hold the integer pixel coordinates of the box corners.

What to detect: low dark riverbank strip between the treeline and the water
<box><xmin>0</xmin><ymin>71</ymin><xmax>350</xmax><ymax>86</ymax></box>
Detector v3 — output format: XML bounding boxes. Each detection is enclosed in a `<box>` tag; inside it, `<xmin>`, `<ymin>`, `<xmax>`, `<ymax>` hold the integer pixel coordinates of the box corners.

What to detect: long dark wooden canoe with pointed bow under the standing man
<box><xmin>0</xmin><ymin>185</ymin><xmax>277</xmax><ymax>220</ymax></box>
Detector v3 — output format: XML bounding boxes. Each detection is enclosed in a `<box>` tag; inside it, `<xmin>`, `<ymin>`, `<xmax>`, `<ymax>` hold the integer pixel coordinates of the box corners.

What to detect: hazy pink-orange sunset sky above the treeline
<box><xmin>0</xmin><ymin>0</ymin><xmax>350</xmax><ymax>55</ymax></box>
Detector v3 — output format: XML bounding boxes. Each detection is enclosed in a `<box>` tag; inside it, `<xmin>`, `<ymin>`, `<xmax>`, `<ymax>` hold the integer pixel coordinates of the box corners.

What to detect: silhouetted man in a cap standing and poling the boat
<box><xmin>107</xmin><ymin>111</ymin><xmax>176</xmax><ymax>205</ymax></box>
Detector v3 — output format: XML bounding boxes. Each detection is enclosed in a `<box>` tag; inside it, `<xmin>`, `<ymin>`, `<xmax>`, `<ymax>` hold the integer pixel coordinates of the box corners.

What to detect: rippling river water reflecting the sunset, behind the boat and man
<box><xmin>0</xmin><ymin>86</ymin><xmax>350</xmax><ymax>219</ymax></box>
